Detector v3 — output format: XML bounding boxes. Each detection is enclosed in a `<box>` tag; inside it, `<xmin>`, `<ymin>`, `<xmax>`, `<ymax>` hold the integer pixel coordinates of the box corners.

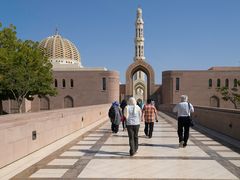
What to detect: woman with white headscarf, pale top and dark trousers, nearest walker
<box><xmin>124</xmin><ymin>97</ymin><xmax>142</xmax><ymax>156</ymax></box>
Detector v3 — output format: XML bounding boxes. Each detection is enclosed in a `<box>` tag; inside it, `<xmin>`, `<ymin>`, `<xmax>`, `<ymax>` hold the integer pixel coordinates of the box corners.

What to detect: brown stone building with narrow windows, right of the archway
<box><xmin>162</xmin><ymin>67</ymin><xmax>240</xmax><ymax>108</ymax></box>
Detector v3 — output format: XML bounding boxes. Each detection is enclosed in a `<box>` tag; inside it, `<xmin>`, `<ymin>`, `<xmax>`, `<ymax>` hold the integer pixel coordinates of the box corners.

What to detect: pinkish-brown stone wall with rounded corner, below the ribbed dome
<box><xmin>3</xmin><ymin>70</ymin><xmax>119</xmax><ymax>113</ymax></box>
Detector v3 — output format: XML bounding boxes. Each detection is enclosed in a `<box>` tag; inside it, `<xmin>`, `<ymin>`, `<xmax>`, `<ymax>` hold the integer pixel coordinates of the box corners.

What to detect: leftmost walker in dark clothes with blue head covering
<box><xmin>108</xmin><ymin>101</ymin><xmax>122</xmax><ymax>133</ymax></box>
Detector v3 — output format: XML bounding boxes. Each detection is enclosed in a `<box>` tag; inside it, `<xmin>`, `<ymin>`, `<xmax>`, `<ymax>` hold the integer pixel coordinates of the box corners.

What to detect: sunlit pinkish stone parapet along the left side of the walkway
<box><xmin>0</xmin><ymin>104</ymin><xmax>110</xmax><ymax>168</ymax></box>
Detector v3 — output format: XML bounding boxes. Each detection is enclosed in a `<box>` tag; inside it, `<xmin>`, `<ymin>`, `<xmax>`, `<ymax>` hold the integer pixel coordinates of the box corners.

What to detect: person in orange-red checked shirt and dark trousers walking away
<box><xmin>142</xmin><ymin>99</ymin><xmax>157</xmax><ymax>138</ymax></box>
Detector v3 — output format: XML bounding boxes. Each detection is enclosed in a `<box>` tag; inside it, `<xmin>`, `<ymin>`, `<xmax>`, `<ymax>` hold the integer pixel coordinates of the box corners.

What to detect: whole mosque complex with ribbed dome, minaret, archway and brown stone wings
<box><xmin>3</xmin><ymin>8</ymin><xmax>240</xmax><ymax>113</ymax></box>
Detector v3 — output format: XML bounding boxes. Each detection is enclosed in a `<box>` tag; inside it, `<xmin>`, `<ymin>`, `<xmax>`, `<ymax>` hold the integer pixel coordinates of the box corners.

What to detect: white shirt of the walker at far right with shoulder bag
<box><xmin>173</xmin><ymin>102</ymin><xmax>194</xmax><ymax>117</ymax></box>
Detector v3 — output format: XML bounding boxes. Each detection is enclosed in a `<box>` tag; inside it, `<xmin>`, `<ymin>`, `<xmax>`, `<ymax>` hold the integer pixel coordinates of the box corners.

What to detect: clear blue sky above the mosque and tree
<box><xmin>0</xmin><ymin>0</ymin><xmax>240</xmax><ymax>83</ymax></box>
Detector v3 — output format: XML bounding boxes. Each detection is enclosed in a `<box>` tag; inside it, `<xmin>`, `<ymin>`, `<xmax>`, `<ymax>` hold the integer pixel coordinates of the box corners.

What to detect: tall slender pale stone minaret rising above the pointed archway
<box><xmin>134</xmin><ymin>8</ymin><xmax>145</xmax><ymax>61</ymax></box>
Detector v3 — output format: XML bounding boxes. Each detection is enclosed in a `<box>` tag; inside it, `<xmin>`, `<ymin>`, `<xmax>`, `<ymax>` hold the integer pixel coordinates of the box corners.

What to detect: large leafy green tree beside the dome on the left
<box><xmin>0</xmin><ymin>21</ymin><xmax>56</xmax><ymax>112</ymax></box>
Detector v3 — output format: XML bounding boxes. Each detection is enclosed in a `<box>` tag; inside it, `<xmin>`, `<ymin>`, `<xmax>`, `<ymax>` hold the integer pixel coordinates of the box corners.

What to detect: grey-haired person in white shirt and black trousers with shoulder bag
<box><xmin>173</xmin><ymin>95</ymin><xmax>194</xmax><ymax>147</ymax></box>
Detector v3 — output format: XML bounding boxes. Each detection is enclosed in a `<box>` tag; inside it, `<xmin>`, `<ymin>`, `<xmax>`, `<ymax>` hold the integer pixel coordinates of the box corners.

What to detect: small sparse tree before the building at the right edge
<box><xmin>217</xmin><ymin>81</ymin><xmax>240</xmax><ymax>109</ymax></box>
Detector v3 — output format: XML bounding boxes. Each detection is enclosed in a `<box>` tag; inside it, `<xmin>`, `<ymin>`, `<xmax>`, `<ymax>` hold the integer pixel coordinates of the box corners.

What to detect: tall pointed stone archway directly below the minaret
<box><xmin>126</xmin><ymin>60</ymin><xmax>155</xmax><ymax>100</ymax></box>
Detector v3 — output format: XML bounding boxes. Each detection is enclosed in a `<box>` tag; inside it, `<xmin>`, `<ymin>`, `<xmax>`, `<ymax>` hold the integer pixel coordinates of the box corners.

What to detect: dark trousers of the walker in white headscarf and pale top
<box><xmin>127</xmin><ymin>125</ymin><xmax>140</xmax><ymax>156</ymax></box>
